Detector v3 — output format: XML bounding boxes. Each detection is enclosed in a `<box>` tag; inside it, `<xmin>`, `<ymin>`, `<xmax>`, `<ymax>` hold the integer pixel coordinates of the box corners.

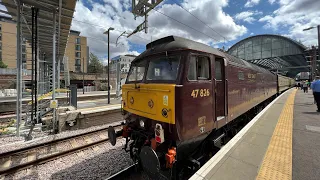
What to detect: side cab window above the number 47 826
<box><xmin>188</xmin><ymin>56</ymin><xmax>210</xmax><ymax>81</ymax></box>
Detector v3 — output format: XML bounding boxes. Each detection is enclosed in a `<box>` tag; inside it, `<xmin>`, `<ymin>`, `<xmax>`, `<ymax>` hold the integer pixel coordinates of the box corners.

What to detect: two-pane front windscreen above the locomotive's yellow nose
<box><xmin>128</xmin><ymin>56</ymin><xmax>180</xmax><ymax>82</ymax></box>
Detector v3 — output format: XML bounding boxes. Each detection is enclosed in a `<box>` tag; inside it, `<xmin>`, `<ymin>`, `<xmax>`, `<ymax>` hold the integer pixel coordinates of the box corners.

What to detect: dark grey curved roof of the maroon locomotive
<box><xmin>133</xmin><ymin>36</ymin><xmax>271</xmax><ymax>73</ymax></box>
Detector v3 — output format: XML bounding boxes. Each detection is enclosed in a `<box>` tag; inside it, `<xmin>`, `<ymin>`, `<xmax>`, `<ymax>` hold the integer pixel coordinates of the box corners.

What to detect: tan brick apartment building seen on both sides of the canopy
<box><xmin>0</xmin><ymin>16</ymin><xmax>89</xmax><ymax>72</ymax></box>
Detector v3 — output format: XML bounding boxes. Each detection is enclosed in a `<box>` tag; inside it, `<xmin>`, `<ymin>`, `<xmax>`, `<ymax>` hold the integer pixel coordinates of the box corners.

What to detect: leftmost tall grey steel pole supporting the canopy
<box><xmin>16</xmin><ymin>0</ymin><xmax>22</xmax><ymax>136</ymax></box>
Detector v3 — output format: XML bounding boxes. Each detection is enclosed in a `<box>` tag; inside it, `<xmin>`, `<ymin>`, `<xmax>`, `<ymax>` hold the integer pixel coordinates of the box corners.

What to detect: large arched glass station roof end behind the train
<box><xmin>228</xmin><ymin>34</ymin><xmax>310</xmax><ymax>77</ymax></box>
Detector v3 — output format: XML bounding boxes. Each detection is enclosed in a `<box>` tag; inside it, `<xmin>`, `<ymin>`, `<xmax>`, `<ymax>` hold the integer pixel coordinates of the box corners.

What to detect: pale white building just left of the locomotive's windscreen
<box><xmin>110</xmin><ymin>54</ymin><xmax>137</xmax><ymax>73</ymax></box>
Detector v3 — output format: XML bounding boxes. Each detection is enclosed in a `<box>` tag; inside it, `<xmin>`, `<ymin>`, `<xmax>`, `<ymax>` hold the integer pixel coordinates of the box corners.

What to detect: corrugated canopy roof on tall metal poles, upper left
<box><xmin>0</xmin><ymin>0</ymin><xmax>76</xmax><ymax>57</ymax></box>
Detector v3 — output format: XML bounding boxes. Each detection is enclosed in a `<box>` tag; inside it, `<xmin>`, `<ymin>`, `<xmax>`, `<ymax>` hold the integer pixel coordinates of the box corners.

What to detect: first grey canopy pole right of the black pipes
<box><xmin>52</xmin><ymin>11</ymin><xmax>57</xmax><ymax>134</ymax></box>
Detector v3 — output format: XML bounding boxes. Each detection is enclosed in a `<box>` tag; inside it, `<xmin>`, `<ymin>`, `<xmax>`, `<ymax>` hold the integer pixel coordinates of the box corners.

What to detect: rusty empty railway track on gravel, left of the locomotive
<box><xmin>0</xmin><ymin>123</ymin><xmax>121</xmax><ymax>175</ymax></box>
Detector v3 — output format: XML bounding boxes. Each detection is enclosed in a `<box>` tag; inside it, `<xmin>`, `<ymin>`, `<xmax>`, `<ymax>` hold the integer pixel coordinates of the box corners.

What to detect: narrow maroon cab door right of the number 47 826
<box><xmin>214</xmin><ymin>57</ymin><xmax>226</xmax><ymax>121</ymax></box>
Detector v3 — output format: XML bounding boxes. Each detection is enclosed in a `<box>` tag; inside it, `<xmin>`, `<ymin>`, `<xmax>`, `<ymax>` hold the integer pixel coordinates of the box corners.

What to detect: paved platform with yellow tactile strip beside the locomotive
<box><xmin>190</xmin><ymin>89</ymin><xmax>320</xmax><ymax>180</ymax></box>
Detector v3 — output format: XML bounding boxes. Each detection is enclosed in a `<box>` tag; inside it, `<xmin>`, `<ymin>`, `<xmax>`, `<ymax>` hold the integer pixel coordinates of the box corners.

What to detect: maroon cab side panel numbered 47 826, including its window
<box><xmin>176</xmin><ymin>53</ymin><xmax>214</xmax><ymax>139</ymax></box>
